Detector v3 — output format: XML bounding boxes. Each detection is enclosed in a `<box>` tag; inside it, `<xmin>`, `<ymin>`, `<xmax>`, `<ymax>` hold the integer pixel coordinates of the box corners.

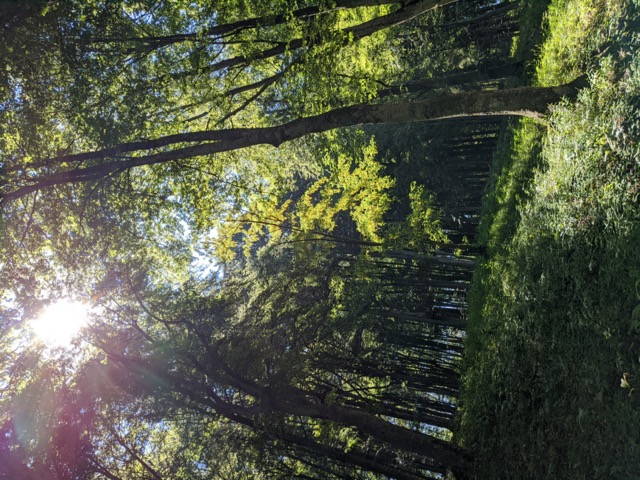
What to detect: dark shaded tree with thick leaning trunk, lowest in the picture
<box><xmin>76</xmin><ymin>242</ymin><xmax>467</xmax><ymax>478</ymax></box>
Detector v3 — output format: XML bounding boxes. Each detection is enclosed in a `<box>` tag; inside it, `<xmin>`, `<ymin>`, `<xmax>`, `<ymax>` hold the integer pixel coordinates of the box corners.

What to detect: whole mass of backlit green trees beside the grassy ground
<box><xmin>0</xmin><ymin>0</ymin><xmax>584</xmax><ymax>480</ymax></box>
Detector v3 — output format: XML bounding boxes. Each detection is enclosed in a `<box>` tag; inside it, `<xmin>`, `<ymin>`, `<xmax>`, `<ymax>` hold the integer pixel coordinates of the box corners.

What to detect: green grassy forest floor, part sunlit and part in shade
<box><xmin>456</xmin><ymin>0</ymin><xmax>640</xmax><ymax>480</ymax></box>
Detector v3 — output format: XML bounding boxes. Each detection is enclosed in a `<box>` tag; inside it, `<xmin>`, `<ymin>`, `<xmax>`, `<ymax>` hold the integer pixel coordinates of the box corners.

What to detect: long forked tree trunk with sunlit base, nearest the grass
<box><xmin>1</xmin><ymin>77</ymin><xmax>585</xmax><ymax>202</ymax></box>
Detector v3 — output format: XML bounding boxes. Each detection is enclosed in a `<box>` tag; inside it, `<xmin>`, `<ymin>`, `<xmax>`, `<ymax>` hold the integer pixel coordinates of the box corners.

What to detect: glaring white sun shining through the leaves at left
<box><xmin>31</xmin><ymin>299</ymin><xmax>89</xmax><ymax>347</ymax></box>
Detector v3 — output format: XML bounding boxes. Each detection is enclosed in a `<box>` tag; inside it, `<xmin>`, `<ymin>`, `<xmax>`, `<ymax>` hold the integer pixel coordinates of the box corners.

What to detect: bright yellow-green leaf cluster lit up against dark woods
<box><xmin>214</xmin><ymin>137</ymin><xmax>394</xmax><ymax>261</ymax></box>
